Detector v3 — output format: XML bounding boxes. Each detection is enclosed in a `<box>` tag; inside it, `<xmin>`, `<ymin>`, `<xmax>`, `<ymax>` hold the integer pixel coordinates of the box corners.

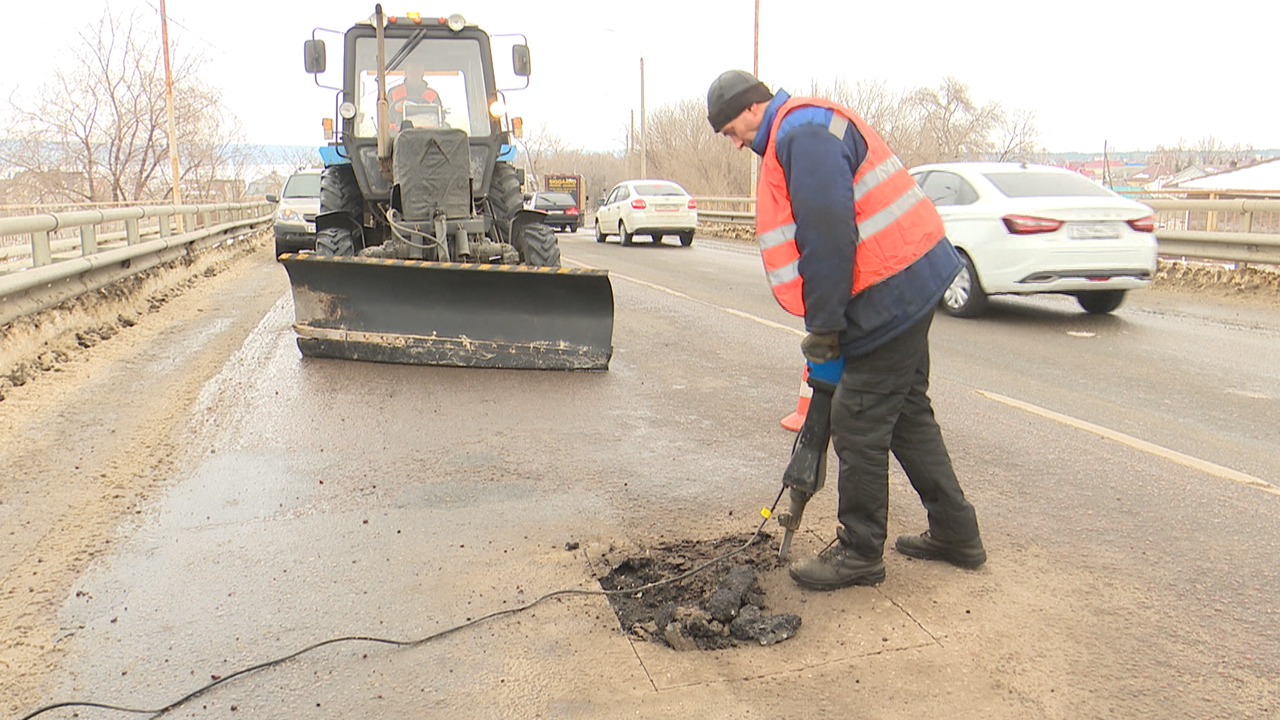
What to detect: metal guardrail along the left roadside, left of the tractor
<box><xmin>0</xmin><ymin>201</ymin><xmax>275</xmax><ymax>324</ymax></box>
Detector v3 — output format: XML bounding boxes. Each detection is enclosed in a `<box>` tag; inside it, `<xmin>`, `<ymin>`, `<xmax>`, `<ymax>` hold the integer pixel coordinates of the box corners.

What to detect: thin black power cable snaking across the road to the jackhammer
<box><xmin>18</xmin><ymin>481</ymin><xmax>794</xmax><ymax>720</ymax></box>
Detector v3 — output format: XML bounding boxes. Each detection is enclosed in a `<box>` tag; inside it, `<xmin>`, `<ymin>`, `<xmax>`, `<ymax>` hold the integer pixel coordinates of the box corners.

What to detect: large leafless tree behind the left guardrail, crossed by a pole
<box><xmin>3</xmin><ymin>10</ymin><xmax>236</xmax><ymax>201</ymax></box>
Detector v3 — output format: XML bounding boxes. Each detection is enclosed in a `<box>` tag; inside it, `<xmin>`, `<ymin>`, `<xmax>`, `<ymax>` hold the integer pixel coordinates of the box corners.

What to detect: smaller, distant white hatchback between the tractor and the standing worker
<box><xmin>595</xmin><ymin>179</ymin><xmax>698</xmax><ymax>247</ymax></box>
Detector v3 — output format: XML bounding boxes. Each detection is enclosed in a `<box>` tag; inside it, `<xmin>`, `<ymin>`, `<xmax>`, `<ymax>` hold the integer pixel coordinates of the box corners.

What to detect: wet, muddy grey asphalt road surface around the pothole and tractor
<box><xmin>0</xmin><ymin>231</ymin><xmax>1280</xmax><ymax>720</ymax></box>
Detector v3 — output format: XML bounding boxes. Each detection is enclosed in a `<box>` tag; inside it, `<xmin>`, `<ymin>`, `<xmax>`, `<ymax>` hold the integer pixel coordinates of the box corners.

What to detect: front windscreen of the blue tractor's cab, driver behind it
<box><xmin>355</xmin><ymin>37</ymin><xmax>492</xmax><ymax>137</ymax></box>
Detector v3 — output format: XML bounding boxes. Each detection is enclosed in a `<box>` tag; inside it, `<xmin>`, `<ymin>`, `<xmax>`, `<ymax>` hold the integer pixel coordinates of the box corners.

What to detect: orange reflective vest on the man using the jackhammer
<box><xmin>755</xmin><ymin>97</ymin><xmax>943</xmax><ymax>316</ymax></box>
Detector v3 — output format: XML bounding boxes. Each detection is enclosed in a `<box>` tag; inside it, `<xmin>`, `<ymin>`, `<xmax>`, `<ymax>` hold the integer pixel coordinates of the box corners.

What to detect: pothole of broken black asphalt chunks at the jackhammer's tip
<box><xmin>599</xmin><ymin>533</ymin><xmax>800</xmax><ymax>651</ymax></box>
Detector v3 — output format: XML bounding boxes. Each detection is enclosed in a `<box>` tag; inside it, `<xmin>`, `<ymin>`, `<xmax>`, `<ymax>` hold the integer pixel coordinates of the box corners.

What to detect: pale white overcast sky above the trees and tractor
<box><xmin>0</xmin><ymin>0</ymin><xmax>1280</xmax><ymax>152</ymax></box>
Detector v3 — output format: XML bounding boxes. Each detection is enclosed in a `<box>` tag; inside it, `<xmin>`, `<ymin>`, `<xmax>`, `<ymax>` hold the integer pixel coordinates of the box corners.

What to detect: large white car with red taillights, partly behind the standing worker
<box><xmin>911</xmin><ymin>163</ymin><xmax>1156</xmax><ymax>318</ymax></box>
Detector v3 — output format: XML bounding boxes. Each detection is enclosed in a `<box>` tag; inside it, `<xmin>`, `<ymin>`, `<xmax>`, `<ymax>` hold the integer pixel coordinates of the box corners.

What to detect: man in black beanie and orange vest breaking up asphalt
<box><xmin>707</xmin><ymin>70</ymin><xmax>987</xmax><ymax>589</ymax></box>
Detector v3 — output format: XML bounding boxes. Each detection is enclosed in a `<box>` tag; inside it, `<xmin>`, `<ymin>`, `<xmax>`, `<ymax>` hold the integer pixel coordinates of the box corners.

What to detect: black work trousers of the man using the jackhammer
<box><xmin>831</xmin><ymin>307</ymin><xmax>978</xmax><ymax>557</ymax></box>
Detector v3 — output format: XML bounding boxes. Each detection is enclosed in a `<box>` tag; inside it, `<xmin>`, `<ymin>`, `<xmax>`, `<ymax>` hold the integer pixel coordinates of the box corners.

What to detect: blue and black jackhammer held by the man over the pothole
<box><xmin>777</xmin><ymin>357</ymin><xmax>845</xmax><ymax>562</ymax></box>
